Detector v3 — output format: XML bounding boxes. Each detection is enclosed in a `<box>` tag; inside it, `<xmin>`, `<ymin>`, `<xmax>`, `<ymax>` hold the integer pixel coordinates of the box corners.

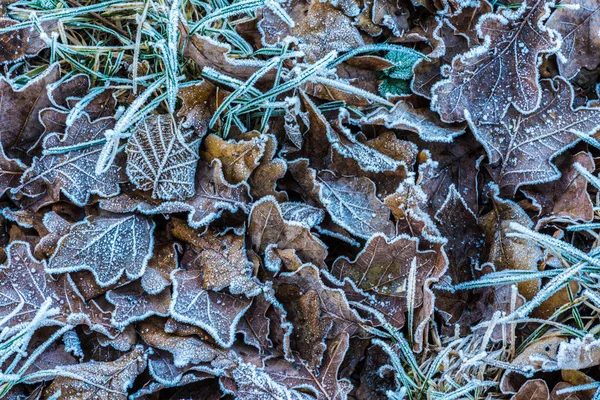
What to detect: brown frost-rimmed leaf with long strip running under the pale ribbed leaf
<box><xmin>100</xmin><ymin>160</ymin><xmax>251</xmax><ymax>228</ymax></box>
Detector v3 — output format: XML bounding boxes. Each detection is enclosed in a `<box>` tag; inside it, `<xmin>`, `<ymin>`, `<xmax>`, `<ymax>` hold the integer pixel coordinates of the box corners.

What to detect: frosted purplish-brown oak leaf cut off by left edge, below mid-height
<box><xmin>0</xmin><ymin>241</ymin><xmax>115</xmax><ymax>335</ymax></box>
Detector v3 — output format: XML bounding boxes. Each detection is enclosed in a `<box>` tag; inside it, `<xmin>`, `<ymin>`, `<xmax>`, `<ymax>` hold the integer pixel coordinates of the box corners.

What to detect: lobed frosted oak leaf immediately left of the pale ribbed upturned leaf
<box><xmin>20</xmin><ymin>113</ymin><xmax>124</xmax><ymax>206</ymax></box>
